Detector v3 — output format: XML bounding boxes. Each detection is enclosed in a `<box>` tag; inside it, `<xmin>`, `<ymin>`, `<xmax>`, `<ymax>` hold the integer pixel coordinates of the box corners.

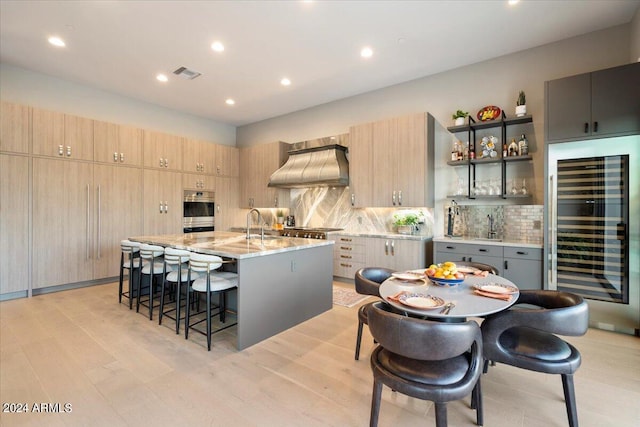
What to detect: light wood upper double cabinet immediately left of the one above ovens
<box><xmin>143</xmin><ymin>130</ymin><xmax>183</xmax><ymax>171</ymax></box>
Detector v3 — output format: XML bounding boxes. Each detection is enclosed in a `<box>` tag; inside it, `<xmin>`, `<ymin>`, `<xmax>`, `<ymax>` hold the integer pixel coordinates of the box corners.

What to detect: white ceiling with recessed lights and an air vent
<box><xmin>0</xmin><ymin>0</ymin><xmax>640</xmax><ymax>126</ymax></box>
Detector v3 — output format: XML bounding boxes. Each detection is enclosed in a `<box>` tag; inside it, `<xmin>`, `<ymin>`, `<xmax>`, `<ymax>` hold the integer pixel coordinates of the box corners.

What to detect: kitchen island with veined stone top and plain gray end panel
<box><xmin>129</xmin><ymin>231</ymin><xmax>333</xmax><ymax>350</ymax></box>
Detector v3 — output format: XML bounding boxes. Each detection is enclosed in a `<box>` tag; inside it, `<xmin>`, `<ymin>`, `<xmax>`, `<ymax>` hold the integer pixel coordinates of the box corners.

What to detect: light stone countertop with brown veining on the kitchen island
<box><xmin>129</xmin><ymin>231</ymin><xmax>334</xmax><ymax>259</ymax></box>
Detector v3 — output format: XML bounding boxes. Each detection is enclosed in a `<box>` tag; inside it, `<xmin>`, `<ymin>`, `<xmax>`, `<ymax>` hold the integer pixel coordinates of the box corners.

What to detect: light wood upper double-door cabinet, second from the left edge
<box><xmin>32</xmin><ymin>108</ymin><xmax>93</xmax><ymax>161</ymax></box>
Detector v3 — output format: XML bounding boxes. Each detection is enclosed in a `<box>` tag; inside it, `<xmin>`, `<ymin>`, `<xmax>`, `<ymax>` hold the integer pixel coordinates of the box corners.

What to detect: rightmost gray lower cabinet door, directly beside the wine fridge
<box><xmin>502</xmin><ymin>246</ymin><xmax>542</xmax><ymax>289</ymax></box>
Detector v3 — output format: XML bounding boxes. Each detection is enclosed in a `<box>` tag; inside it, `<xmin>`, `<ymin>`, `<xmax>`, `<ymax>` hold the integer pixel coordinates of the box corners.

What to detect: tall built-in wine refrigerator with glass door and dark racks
<box><xmin>544</xmin><ymin>135</ymin><xmax>640</xmax><ymax>336</ymax></box>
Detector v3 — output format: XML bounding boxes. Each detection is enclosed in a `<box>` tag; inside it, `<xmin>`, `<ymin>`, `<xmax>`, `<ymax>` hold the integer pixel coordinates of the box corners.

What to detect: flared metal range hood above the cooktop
<box><xmin>269</xmin><ymin>134</ymin><xmax>349</xmax><ymax>188</ymax></box>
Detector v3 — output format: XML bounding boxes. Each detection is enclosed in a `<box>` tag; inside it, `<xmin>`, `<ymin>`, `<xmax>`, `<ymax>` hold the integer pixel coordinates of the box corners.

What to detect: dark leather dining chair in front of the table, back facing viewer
<box><xmin>368</xmin><ymin>301</ymin><xmax>483</xmax><ymax>427</ymax></box>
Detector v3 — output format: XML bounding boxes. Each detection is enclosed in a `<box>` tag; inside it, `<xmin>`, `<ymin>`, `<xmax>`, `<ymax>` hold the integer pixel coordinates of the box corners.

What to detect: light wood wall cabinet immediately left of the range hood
<box><xmin>240</xmin><ymin>142</ymin><xmax>290</xmax><ymax>208</ymax></box>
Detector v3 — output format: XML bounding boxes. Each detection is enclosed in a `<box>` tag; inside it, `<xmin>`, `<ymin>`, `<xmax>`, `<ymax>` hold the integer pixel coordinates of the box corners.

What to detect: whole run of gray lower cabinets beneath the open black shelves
<box><xmin>434</xmin><ymin>242</ymin><xmax>542</xmax><ymax>289</ymax></box>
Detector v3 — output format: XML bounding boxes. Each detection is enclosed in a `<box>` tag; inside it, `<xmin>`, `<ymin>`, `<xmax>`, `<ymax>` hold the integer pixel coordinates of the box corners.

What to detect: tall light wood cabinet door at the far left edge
<box><xmin>0</xmin><ymin>154</ymin><xmax>31</xmax><ymax>295</ymax></box>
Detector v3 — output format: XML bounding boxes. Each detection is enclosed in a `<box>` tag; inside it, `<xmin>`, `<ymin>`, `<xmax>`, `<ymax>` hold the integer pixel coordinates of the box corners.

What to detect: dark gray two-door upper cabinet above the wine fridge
<box><xmin>545</xmin><ymin>63</ymin><xmax>640</xmax><ymax>142</ymax></box>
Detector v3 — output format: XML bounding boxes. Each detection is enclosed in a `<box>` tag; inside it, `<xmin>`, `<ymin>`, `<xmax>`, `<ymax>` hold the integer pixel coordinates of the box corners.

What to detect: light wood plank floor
<box><xmin>0</xmin><ymin>283</ymin><xmax>640</xmax><ymax>427</ymax></box>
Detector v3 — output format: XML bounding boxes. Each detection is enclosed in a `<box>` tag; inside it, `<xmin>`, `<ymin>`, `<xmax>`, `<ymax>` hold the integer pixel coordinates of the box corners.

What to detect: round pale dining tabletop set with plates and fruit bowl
<box><xmin>379</xmin><ymin>274</ymin><xmax>520</xmax><ymax>321</ymax></box>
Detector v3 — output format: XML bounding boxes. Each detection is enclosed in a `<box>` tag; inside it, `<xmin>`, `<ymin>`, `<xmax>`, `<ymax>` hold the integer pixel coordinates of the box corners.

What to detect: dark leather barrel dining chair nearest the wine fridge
<box><xmin>482</xmin><ymin>290</ymin><xmax>589</xmax><ymax>427</ymax></box>
